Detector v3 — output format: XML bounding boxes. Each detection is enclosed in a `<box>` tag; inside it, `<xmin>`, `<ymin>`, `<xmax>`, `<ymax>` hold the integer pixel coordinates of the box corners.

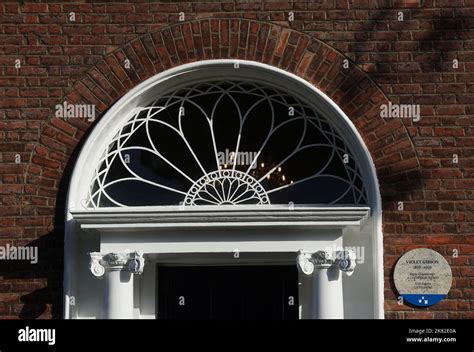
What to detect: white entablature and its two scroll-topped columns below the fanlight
<box><xmin>72</xmin><ymin>206</ymin><xmax>369</xmax><ymax>319</ymax></box>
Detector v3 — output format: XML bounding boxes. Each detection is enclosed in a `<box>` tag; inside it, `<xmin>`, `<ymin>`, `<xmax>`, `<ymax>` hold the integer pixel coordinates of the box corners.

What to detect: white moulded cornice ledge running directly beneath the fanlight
<box><xmin>70</xmin><ymin>206</ymin><xmax>370</xmax><ymax>231</ymax></box>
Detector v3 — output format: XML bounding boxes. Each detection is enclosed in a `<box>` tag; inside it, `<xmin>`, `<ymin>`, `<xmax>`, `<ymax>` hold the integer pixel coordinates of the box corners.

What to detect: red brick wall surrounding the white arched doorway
<box><xmin>0</xmin><ymin>0</ymin><xmax>474</xmax><ymax>318</ymax></box>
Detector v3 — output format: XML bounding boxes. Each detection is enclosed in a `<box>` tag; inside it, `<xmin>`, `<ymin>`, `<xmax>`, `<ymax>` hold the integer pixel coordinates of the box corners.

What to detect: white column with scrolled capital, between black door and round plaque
<box><xmin>297</xmin><ymin>251</ymin><xmax>355</xmax><ymax>319</ymax></box>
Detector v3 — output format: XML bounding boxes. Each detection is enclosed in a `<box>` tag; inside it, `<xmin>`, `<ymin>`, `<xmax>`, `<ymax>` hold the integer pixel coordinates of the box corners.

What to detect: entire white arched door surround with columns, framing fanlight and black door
<box><xmin>64</xmin><ymin>60</ymin><xmax>383</xmax><ymax>318</ymax></box>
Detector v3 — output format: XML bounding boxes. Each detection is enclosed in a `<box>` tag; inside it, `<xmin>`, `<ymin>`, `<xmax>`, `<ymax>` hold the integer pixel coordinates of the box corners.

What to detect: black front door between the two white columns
<box><xmin>158</xmin><ymin>265</ymin><xmax>298</xmax><ymax>320</ymax></box>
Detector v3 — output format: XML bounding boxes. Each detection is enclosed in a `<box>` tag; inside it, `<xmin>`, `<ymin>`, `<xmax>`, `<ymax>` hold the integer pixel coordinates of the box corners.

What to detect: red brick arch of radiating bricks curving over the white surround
<box><xmin>26</xmin><ymin>19</ymin><xmax>420</xmax><ymax>214</ymax></box>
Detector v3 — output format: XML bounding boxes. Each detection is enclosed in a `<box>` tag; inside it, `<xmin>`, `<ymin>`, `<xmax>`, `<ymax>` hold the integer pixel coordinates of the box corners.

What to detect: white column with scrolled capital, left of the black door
<box><xmin>89</xmin><ymin>251</ymin><xmax>145</xmax><ymax>319</ymax></box>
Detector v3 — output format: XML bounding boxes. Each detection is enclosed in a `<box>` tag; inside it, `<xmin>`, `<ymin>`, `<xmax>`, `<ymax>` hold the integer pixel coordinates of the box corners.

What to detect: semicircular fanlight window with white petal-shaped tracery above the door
<box><xmin>88</xmin><ymin>80</ymin><xmax>367</xmax><ymax>208</ymax></box>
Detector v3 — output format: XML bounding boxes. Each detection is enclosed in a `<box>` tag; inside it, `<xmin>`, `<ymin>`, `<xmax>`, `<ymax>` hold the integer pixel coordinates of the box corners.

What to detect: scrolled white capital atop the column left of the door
<box><xmin>89</xmin><ymin>251</ymin><xmax>145</xmax><ymax>277</ymax></box>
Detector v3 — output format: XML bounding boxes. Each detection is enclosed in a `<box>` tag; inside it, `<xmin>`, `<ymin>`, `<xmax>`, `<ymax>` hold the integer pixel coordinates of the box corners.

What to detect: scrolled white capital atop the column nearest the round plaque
<box><xmin>296</xmin><ymin>249</ymin><xmax>356</xmax><ymax>276</ymax></box>
